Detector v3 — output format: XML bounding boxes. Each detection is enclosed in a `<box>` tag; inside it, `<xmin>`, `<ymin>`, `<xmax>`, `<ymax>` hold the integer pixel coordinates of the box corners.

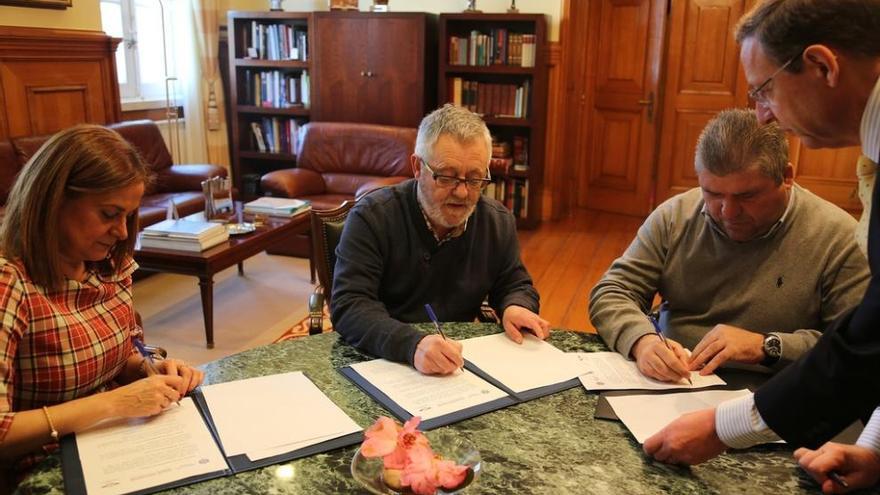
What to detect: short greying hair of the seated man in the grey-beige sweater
<box><xmin>694</xmin><ymin>108</ymin><xmax>788</xmax><ymax>185</ymax></box>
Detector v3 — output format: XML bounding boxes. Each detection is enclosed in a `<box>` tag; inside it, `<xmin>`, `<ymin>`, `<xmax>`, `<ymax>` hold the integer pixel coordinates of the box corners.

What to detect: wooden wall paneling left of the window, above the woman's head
<box><xmin>0</xmin><ymin>26</ymin><xmax>121</xmax><ymax>138</ymax></box>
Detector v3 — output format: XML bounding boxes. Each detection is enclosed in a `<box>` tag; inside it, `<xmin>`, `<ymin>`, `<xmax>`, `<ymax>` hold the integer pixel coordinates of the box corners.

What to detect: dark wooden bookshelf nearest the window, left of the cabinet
<box><xmin>227</xmin><ymin>11</ymin><xmax>315</xmax><ymax>200</ymax></box>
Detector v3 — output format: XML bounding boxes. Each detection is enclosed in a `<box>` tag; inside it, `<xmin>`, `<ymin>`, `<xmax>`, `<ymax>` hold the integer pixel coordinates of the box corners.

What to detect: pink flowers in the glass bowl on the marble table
<box><xmin>361</xmin><ymin>416</ymin><xmax>468</xmax><ymax>495</ymax></box>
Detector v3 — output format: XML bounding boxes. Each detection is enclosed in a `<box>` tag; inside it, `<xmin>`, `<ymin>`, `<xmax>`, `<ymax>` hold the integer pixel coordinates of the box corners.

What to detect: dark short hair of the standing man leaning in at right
<box><xmin>736</xmin><ymin>0</ymin><xmax>880</xmax><ymax>72</ymax></box>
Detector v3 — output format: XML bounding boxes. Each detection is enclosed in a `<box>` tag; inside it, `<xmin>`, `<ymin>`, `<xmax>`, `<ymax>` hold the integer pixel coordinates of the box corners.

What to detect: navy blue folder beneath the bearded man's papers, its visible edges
<box><xmin>339</xmin><ymin>360</ymin><xmax>580</xmax><ymax>430</ymax></box>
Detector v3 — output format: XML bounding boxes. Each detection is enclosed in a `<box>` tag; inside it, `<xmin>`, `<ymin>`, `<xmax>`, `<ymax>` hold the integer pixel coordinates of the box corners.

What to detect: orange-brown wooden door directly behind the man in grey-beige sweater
<box><xmin>655</xmin><ymin>0</ymin><xmax>752</xmax><ymax>205</ymax></box>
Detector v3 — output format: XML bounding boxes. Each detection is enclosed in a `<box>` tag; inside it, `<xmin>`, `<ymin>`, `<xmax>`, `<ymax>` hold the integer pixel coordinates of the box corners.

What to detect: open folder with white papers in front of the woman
<box><xmin>61</xmin><ymin>372</ymin><xmax>363</xmax><ymax>495</ymax></box>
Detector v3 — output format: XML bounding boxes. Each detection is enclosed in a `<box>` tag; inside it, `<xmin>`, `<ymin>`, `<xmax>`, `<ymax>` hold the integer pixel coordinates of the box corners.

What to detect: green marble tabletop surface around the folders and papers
<box><xmin>17</xmin><ymin>324</ymin><xmax>868</xmax><ymax>495</ymax></box>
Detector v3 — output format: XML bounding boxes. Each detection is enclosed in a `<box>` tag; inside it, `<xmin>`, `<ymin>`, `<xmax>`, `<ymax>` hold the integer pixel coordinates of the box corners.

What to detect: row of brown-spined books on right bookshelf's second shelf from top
<box><xmin>447</xmin><ymin>77</ymin><xmax>531</xmax><ymax>119</ymax></box>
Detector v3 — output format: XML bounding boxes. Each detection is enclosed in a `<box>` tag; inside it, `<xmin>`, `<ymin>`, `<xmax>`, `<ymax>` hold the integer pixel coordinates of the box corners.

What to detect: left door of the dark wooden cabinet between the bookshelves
<box><xmin>312</xmin><ymin>12</ymin><xmax>371</xmax><ymax>122</ymax></box>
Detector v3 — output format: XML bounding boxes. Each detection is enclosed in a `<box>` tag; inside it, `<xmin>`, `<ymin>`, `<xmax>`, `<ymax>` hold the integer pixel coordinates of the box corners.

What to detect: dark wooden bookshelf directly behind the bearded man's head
<box><xmin>437</xmin><ymin>13</ymin><xmax>547</xmax><ymax>228</ymax></box>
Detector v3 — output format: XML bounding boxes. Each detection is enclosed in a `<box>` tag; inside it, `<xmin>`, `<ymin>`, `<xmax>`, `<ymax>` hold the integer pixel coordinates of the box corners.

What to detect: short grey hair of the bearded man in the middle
<box><xmin>416</xmin><ymin>103</ymin><xmax>492</xmax><ymax>167</ymax></box>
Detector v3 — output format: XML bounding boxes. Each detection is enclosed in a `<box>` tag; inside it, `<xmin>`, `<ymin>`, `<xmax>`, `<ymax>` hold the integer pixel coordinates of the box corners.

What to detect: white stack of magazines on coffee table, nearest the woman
<box><xmin>141</xmin><ymin>220</ymin><xmax>229</xmax><ymax>252</ymax></box>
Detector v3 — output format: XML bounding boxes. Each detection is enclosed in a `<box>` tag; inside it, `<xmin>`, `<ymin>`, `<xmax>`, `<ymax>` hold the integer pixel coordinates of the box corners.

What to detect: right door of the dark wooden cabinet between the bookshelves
<box><xmin>366</xmin><ymin>16</ymin><xmax>426</xmax><ymax>127</ymax></box>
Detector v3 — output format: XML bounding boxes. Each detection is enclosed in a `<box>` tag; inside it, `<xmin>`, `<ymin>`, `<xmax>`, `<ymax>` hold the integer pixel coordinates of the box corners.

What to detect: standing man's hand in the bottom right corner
<box><xmin>794</xmin><ymin>442</ymin><xmax>880</xmax><ymax>493</ymax></box>
